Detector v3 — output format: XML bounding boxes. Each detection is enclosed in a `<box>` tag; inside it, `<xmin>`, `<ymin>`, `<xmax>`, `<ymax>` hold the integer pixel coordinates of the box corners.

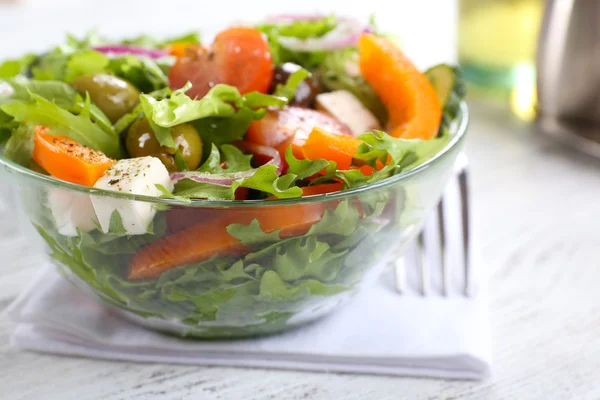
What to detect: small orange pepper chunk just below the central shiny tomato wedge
<box><xmin>302</xmin><ymin>128</ymin><xmax>362</xmax><ymax>169</ymax></box>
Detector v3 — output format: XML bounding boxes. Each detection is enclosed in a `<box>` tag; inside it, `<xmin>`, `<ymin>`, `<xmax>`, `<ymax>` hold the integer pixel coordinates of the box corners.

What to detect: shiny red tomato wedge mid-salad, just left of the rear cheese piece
<box><xmin>246</xmin><ymin>107</ymin><xmax>352</xmax><ymax>160</ymax></box>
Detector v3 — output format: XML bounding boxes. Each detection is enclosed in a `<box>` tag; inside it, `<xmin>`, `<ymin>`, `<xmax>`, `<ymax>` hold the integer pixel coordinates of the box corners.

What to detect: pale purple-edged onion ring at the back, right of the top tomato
<box><xmin>271</xmin><ymin>15</ymin><xmax>370</xmax><ymax>51</ymax></box>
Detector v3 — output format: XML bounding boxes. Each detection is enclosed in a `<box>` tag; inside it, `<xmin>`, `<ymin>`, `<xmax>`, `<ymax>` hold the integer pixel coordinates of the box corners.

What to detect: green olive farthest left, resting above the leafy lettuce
<box><xmin>71</xmin><ymin>74</ymin><xmax>140</xmax><ymax>124</ymax></box>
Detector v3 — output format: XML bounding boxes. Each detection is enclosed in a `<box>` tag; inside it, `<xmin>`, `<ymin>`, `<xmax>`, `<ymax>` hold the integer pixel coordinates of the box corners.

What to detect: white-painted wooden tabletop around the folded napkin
<box><xmin>0</xmin><ymin>99</ymin><xmax>600</xmax><ymax>400</ymax></box>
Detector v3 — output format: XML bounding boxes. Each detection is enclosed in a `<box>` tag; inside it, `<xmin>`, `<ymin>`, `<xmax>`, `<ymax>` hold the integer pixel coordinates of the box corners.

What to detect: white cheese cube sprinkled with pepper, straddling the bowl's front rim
<box><xmin>92</xmin><ymin>157</ymin><xmax>173</xmax><ymax>235</ymax></box>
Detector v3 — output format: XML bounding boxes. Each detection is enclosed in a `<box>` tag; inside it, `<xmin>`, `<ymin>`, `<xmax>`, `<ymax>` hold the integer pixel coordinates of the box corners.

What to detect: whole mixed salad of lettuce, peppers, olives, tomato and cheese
<box><xmin>0</xmin><ymin>16</ymin><xmax>464</xmax><ymax>337</ymax></box>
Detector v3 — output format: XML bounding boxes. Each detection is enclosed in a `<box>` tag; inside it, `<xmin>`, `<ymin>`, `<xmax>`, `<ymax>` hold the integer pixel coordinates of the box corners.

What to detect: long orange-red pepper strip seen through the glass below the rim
<box><xmin>129</xmin><ymin>203</ymin><xmax>328</xmax><ymax>279</ymax></box>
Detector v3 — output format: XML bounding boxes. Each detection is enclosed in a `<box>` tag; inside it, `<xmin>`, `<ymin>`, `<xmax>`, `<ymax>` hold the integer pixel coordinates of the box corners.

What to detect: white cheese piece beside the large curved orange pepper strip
<box><xmin>316</xmin><ymin>90</ymin><xmax>381</xmax><ymax>136</ymax></box>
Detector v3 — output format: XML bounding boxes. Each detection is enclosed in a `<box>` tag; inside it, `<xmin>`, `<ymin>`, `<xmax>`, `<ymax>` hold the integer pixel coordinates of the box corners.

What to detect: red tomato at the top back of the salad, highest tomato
<box><xmin>169</xmin><ymin>26</ymin><xmax>273</xmax><ymax>98</ymax></box>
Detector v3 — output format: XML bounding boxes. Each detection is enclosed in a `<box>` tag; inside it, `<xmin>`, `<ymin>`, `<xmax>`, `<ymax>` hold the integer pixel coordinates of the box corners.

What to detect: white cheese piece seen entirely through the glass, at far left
<box><xmin>48</xmin><ymin>188</ymin><xmax>96</xmax><ymax>236</ymax></box>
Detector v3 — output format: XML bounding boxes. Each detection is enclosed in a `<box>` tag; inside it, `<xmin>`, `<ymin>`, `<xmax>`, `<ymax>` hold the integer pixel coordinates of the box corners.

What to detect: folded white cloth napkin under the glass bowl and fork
<box><xmin>7</xmin><ymin>172</ymin><xmax>491</xmax><ymax>379</ymax></box>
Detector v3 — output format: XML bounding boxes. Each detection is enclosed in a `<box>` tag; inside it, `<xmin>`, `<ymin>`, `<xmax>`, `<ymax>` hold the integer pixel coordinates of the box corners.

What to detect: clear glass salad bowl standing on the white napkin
<box><xmin>0</xmin><ymin>103</ymin><xmax>468</xmax><ymax>338</ymax></box>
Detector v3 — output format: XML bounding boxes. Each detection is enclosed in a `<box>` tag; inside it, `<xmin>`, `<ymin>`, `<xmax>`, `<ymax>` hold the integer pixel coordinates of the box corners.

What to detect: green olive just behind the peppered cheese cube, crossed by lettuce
<box><xmin>125</xmin><ymin>118</ymin><xmax>202</xmax><ymax>172</ymax></box>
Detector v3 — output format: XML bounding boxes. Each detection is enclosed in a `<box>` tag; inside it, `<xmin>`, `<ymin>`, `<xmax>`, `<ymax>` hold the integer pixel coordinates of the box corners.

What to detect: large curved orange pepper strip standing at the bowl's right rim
<box><xmin>358</xmin><ymin>34</ymin><xmax>442</xmax><ymax>140</ymax></box>
